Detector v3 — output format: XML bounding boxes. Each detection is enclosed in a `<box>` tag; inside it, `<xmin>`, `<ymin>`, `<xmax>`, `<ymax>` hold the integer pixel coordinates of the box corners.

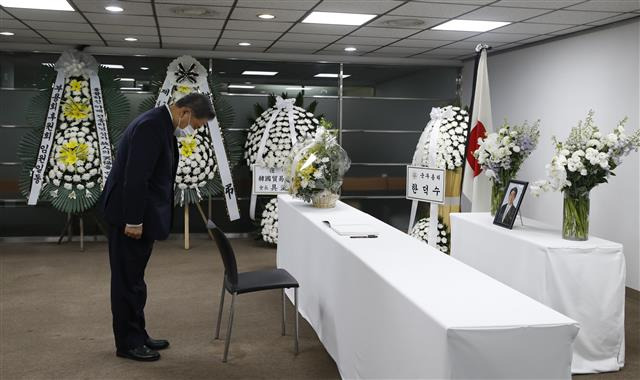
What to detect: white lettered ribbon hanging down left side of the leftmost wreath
<box><xmin>27</xmin><ymin>69</ymin><xmax>65</xmax><ymax>206</ymax></box>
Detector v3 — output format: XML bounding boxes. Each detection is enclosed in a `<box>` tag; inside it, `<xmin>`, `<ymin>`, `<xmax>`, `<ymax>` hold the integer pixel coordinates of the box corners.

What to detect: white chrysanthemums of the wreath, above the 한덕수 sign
<box><xmin>418</xmin><ymin>106</ymin><xmax>469</xmax><ymax>170</ymax></box>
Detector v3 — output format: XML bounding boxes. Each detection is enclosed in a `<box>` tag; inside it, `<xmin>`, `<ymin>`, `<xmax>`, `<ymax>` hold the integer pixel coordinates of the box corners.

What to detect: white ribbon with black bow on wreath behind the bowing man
<box><xmin>156</xmin><ymin>56</ymin><xmax>240</xmax><ymax>221</ymax></box>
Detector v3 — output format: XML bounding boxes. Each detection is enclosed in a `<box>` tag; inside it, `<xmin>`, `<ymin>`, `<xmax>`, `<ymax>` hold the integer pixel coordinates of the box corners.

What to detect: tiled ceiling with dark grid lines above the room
<box><xmin>0</xmin><ymin>0</ymin><xmax>640</xmax><ymax>60</ymax></box>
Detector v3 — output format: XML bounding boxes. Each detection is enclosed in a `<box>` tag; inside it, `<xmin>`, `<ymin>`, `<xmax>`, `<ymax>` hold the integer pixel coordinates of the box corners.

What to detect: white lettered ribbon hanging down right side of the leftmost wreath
<box><xmin>89</xmin><ymin>72</ymin><xmax>113</xmax><ymax>188</ymax></box>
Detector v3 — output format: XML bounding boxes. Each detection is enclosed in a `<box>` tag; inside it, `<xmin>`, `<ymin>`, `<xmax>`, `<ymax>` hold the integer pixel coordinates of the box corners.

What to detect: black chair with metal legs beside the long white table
<box><xmin>207</xmin><ymin>221</ymin><xmax>299</xmax><ymax>363</ymax></box>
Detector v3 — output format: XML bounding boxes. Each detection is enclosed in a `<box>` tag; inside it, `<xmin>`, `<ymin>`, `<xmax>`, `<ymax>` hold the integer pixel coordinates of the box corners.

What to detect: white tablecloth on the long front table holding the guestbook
<box><xmin>277</xmin><ymin>195</ymin><xmax>578</xmax><ymax>379</ymax></box>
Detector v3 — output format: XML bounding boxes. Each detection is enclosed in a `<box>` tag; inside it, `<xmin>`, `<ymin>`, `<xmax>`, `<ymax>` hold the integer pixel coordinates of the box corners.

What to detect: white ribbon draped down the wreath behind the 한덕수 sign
<box><xmin>409</xmin><ymin>106</ymin><xmax>454</xmax><ymax>247</ymax></box>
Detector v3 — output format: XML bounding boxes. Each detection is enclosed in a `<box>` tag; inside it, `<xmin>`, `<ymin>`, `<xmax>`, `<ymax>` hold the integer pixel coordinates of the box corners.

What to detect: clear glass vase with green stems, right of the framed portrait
<box><xmin>562</xmin><ymin>192</ymin><xmax>589</xmax><ymax>240</ymax></box>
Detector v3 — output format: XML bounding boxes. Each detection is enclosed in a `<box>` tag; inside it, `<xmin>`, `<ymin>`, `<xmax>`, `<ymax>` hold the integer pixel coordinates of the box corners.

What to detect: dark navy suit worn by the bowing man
<box><xmin>103</xmin><ymin>106</ymin><xmax>178</xmax><ymax>351</ymax></box>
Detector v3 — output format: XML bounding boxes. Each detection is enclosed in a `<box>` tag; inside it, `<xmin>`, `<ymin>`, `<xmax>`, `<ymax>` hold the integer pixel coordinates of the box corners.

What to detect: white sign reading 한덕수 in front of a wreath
<box><xmin>406</xmin><ymin>165</ymin><xmax>445</xmax><ymax>204</ymax></box>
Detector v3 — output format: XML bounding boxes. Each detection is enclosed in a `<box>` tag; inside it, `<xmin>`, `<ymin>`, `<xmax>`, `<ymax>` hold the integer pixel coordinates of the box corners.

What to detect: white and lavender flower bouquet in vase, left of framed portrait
<box><xmin>474</xmin><ymin>121</ymin><xmax>540</xmax><ymax>216</ymax></box>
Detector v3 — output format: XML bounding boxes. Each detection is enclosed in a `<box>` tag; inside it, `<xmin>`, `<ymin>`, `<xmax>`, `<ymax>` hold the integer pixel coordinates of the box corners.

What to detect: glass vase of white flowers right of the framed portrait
<box><xmin>531</xmin><ymin>111</ymin><xmax>640</xmax><ymax>240</ymax></box>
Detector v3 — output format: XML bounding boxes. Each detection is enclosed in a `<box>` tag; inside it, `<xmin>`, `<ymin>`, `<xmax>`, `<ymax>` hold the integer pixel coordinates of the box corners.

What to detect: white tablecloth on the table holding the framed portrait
<box><xmin>451</xmin><ymin>213</ymin><xmax>625</xmax><ymax>373</ymax></box>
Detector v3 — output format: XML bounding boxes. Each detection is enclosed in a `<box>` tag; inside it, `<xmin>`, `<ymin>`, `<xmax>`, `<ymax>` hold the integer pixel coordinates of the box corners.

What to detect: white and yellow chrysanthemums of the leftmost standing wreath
<box><xmin>45</xmin><ymin>74</ymin><xmax>102</xmax><ymax>199</ymax></box>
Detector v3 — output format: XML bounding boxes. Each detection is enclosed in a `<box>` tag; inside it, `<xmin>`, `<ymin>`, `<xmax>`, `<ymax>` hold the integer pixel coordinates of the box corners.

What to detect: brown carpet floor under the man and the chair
<box><xmin>0</xmin><ymin>239</ymin><xmax>640</xmax><ymax>380</ymax></box>
